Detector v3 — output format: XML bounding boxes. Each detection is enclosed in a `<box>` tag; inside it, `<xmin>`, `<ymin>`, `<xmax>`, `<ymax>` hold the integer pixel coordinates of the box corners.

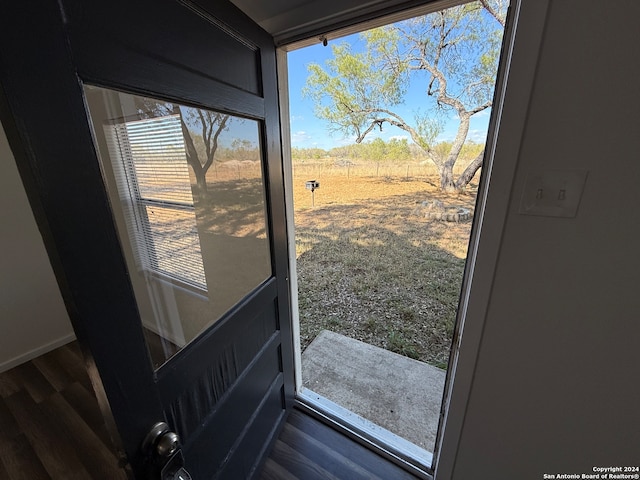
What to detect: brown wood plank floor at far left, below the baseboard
<box><xmin>0</xmin><ymin>342</ymin><xmax>127</xmax><ymax>480</ymax></box>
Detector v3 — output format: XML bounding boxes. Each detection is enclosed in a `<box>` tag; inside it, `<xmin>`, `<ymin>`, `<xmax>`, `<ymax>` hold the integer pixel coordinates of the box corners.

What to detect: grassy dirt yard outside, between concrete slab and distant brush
<box><xmin>294</xmin><ymin>161</ymin><xmax>477</xmax><ymax>367</ymax></box>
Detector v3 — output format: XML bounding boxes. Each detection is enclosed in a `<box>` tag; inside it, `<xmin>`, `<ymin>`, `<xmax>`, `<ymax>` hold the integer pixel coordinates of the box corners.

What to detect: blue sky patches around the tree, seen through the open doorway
<box><xmin>287</xmin><ymin>35</ymin><xmax>490</xmax><ymax>150</ymax></box>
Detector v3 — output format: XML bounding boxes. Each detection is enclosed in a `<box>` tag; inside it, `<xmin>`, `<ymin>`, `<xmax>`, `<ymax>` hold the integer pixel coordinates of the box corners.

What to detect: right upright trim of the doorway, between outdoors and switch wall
<box><xmin>434</xmin><ymin>0</ymin><xmax>549</xmax><ymax>479</ymax></box>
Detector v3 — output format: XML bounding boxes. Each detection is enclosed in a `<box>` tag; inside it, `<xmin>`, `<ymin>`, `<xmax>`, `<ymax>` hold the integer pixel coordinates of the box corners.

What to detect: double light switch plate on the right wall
<box><xmin>519</xmin><ymin>170</ymin><xmax>588</xmax><ymax>218</ymax></box>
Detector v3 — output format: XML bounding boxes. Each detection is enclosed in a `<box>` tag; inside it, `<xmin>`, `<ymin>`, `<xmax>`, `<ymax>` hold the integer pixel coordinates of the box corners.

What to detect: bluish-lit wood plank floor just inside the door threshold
<box><xmin>258</xmin><ymin>409</ymin><xmax>416</xmax><ymax>480</ymax></box>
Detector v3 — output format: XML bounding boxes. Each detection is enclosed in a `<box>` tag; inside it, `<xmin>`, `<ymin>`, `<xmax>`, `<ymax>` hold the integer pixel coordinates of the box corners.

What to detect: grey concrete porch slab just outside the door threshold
<box><xmin>302</xmin><ymin>330</ymin><xmax>446</xmax><ymax>452</ymax></box>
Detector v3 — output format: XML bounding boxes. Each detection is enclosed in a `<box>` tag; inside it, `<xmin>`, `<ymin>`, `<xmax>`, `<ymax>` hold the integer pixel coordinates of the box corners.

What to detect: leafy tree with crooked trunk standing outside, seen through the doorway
<box><xmin>304</xmin><ymin>0</ymin><xmax>506</xmax><ymax>191</ymax></box>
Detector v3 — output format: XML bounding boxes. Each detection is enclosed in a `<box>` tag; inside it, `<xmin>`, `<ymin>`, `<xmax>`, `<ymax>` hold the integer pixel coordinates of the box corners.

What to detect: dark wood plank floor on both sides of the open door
<box><xmin>0</xmin><ymin>342</ymin><xmax>422</xmax><ymax>480</ymax></box>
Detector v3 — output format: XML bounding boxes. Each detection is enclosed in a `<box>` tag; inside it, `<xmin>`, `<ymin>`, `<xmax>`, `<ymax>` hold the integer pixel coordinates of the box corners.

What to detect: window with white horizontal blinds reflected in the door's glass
<box><xmin>105</xmin><ymin>115</ymin><xmax>207</xmax><ymax>291</ymax></box>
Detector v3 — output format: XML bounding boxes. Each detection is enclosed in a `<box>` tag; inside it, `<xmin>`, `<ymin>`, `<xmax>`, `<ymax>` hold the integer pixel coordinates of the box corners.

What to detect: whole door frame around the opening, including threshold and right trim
<box><xmin>278</xmin><ymin>0</ymin><xmax>549</xmax><ymax>479</ymax></box>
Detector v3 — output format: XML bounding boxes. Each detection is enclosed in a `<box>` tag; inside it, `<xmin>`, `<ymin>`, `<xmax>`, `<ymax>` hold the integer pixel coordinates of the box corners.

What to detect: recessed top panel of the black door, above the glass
<box><xmin>64</xmin><ymin>0</ymin><xmax>264</xmax><ymax>95</ymax></box>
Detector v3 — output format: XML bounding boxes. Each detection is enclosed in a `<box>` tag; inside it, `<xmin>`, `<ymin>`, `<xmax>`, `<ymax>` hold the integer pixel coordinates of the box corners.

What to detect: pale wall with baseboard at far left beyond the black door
<box><xmin>0</xmin><ymin>122</ymin><xmax>74</xmax><ymax>372</ymax></box>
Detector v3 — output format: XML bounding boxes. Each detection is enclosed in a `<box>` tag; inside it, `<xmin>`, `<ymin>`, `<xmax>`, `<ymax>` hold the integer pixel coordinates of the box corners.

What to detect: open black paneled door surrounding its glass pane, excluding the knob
<box><xmin>0</xmin><ymin>0</ymin><xmax>293</xmax><ymax>479</ymax></box>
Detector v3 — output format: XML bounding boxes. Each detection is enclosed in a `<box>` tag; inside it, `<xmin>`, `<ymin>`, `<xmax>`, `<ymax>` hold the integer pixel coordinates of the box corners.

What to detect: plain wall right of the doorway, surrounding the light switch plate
<box><xmin>453</xmin><ymin>0</ymin><xmax>640</xmax><ymax>480</ymax></box>
